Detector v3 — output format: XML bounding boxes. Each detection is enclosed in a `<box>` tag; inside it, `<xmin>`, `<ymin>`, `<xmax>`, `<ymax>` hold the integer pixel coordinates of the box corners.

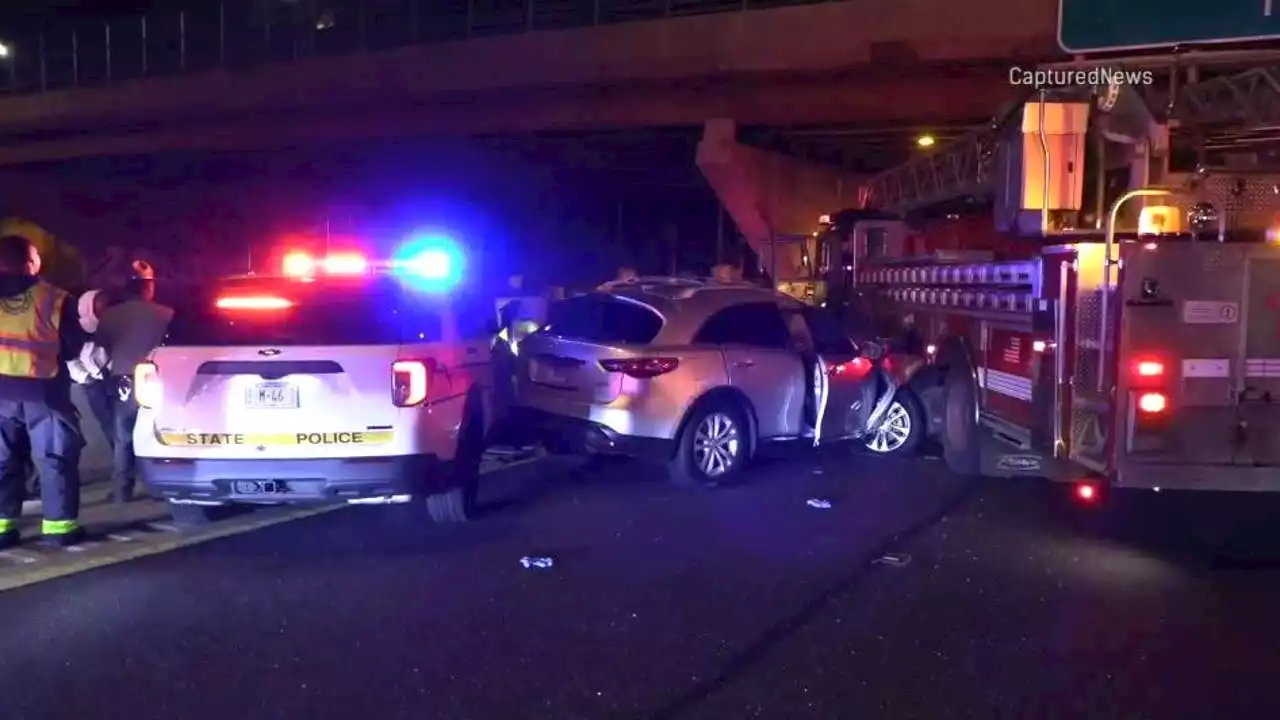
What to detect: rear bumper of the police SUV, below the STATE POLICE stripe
<box><xmin>138</xmin><ymin>455</ymin><xmax>451</xmax><ymax>503</ymax></box>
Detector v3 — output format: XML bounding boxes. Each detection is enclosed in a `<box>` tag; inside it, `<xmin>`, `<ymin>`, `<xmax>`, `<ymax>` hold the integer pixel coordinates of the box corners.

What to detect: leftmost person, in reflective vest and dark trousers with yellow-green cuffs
<box><xmin>0</xmin><ymin>234</ymin><xmax>84</xmax><ymax>547</ymax></box>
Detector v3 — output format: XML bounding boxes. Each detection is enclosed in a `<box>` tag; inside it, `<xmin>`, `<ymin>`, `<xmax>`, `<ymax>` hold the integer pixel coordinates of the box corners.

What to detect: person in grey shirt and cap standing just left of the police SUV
<box><xmin>96</xmin><ymin>260</ymin><xmax>173</xmax><ymax>502</ymax></box>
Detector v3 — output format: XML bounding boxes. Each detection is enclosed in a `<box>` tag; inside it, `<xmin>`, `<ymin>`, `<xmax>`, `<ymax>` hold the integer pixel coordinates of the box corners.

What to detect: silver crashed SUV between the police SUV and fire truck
<box><xmin>516</xmin><ymin>277</ymin><xmax>924</xmax><ymax>483</ymax></box>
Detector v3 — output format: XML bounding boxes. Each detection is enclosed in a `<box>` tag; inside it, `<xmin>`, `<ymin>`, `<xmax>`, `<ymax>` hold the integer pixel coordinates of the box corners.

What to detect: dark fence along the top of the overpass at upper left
<box><xmin>0</xmin><ymin>0</ymin><xmax>838</xmax><ymax>94</ymax></box>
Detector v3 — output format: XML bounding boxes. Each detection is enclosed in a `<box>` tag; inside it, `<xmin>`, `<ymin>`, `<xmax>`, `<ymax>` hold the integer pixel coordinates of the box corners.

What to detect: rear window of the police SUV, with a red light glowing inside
<box><xmin>165</xmin><ymin>278</ymin><xmax>442</xmax><ymax>346</ymax></box>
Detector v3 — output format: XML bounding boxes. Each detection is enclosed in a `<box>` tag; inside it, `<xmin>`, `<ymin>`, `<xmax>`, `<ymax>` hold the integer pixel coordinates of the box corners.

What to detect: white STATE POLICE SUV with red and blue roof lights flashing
<box><xmin>133</xmin><ymin>239</ymin><xmax>493</xmax><ymax>524</ymax></box>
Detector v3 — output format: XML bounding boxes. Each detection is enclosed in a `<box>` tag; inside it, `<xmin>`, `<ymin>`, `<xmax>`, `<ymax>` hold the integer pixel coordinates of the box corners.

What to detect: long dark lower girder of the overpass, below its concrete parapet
<box><xmin>0</xmin><ymin>68</ymin><xmax>1014</xmax><ymax>165</ymax></box>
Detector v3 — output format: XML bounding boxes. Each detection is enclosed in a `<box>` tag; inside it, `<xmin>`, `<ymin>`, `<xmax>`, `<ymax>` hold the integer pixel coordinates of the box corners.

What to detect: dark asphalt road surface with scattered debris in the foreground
<box><xmin>0</xmin><ymin>454</ymin><xmax>1280</xmax><ymax>720</ymax></box>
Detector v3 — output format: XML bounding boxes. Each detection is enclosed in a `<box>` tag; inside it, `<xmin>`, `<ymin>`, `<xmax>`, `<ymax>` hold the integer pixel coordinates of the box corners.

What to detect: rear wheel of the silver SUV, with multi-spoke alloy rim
<box><xmin>667</xmin><ymin>400</ymin><xmax>750</xmax><ymax>486</ymax></box>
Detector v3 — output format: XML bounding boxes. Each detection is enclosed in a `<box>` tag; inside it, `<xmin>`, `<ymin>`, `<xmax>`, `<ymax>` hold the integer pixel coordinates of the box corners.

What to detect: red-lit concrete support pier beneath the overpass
<box><xmin>698</xmin><ymin>119</ymin><xmax>860</xmax><ymax>281</ymax></box>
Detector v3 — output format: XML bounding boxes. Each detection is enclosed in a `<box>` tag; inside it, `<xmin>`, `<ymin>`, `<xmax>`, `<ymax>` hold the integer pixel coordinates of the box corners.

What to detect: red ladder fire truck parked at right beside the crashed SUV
<box><xmin>815</xmin><ymin>78</ymin><xmax>1280</xmax><ymax>497</ymax></box>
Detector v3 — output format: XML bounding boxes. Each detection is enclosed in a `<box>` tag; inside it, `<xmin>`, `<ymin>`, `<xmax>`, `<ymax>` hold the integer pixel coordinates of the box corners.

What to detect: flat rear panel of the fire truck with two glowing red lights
<box><xmin>1117</xmin><ymin>242</ymin><xmax>1280</xmax><ymax>468</ymax></box>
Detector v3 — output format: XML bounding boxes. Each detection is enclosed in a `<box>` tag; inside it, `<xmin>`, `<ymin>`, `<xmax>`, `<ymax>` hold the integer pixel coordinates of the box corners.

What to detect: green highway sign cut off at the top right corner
<box><xmin>1057</xmin><ymin>0</ymin><xmax>1280</xmax><ymax>54</ymax></box>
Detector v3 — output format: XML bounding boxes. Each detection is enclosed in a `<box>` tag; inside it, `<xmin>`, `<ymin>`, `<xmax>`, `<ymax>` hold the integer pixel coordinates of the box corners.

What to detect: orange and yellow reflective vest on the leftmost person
<box><xmin>0</xmin><ymin>281</ymin><xmax>69</xmax><ymax>378</ymax></box>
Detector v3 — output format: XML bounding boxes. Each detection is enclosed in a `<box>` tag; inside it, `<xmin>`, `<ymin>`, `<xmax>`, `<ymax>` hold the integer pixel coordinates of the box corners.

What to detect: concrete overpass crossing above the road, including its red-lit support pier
<box><xmin>0</xmin><ymin>0</ymin><xmax>1056</xmax><ymax>274</ymax></box>
